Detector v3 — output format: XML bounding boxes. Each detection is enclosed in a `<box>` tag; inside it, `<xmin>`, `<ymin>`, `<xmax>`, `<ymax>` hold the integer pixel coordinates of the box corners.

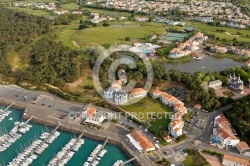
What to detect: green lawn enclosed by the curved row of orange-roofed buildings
<box><xmin>121</xmin><ymin>97</ymin><xmax>172</xmax><ymax>120</ymax></box>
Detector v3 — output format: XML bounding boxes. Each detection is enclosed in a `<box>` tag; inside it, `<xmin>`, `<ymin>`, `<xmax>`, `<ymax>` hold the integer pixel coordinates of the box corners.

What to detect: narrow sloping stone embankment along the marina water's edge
<box><xmin>0</xmin><ymin>100</ymin><xmax>142</xmax><ymax>165</ymax></box>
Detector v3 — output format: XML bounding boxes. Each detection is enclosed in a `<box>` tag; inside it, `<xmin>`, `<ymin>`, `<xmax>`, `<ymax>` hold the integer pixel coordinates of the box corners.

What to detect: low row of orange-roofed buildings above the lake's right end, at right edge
<box><xmin>210</xmin><ymin>45</ymin><xmax>250</xmax><ymax>56</ymax></box>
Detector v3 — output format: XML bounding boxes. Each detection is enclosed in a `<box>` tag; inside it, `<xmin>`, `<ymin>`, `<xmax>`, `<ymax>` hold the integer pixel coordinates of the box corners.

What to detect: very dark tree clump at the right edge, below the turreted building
<box><xmin>224</xmin><ymin>96</ymin><xmax>250</xmax><ymax>144</ymax></box>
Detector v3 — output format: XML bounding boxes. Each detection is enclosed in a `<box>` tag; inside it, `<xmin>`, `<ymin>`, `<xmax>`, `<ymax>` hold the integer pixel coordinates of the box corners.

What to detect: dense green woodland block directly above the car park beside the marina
<box><xmin>16</xmin><ymin>37</ymin><xmax>80</xmax><ymax>87</ymax></box>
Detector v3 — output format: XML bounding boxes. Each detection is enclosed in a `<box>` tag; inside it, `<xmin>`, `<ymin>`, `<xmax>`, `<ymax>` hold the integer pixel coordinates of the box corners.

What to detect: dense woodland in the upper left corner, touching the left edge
<box><xmin>0</xmin><ymin>7</ymin><xmax>51</xmax><ymax>74</ymax></box>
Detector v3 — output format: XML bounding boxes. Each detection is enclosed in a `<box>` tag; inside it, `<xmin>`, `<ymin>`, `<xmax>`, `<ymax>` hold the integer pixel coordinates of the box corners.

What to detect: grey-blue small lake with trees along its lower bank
<box><xmin>166</xmin><ymin>56</ymin><xmax>244</xmax><ymax>73</ymax></box>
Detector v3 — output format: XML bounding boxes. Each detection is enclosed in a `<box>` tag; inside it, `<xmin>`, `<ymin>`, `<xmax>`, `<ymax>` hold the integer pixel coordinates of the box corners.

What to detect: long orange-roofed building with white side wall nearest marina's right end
<box><xmin>126</xmin><ymin>131</ymin><xmax>155</xmax><ymax>152</ymax></box>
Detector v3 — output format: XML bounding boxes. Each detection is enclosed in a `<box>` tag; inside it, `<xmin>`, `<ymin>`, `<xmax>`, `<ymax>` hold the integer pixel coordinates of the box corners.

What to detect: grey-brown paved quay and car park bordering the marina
<box><xmin>0</xmin><ymin>85</ymin><xmax>151</xmax><ymax>166</ymax></box>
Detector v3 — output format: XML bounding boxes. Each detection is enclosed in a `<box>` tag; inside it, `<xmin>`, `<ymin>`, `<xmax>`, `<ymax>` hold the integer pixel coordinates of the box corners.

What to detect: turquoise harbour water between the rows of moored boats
<box><xmin>0</xmin><ymin>106</ymin><xmax>133</xmax><ymax>166</ymax></box>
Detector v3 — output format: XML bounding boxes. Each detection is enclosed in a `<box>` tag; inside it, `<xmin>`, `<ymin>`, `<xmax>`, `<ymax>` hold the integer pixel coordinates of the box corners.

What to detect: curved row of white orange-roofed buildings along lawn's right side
<box><xmin>150</xmin><ymin>89</ymin><xmax>187</xmax><ymax>138</ymax></box>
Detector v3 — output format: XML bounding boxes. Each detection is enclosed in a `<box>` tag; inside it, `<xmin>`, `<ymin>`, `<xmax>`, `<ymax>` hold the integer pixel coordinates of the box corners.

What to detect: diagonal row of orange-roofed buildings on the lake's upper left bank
<box><xmin>169</xmin><ymin>32</ymin><xmax>208</xmax><ymax>58</ymax></box>
